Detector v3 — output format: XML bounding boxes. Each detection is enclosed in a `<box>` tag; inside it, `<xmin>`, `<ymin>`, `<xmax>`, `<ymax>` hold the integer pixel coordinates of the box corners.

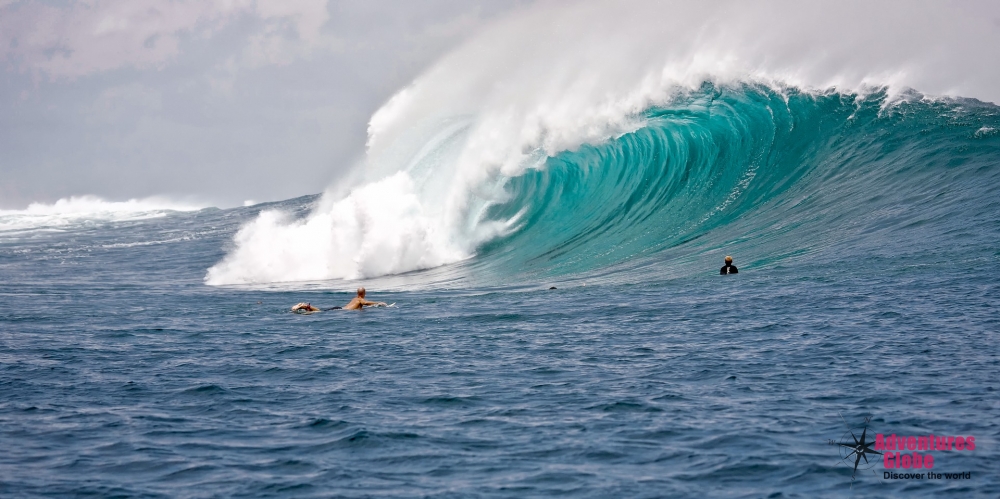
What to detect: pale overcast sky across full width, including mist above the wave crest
<box><xmin>0</xmin><ymin>0</ymin><xmax>1000</xmax><ymax>209</ymax></box>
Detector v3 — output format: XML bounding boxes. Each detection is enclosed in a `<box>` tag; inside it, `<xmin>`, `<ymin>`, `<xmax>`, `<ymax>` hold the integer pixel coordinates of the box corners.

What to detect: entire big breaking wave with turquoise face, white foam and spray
<box><xmin>206</xmin><ymin>2</ymin><xmax>1000</xmax><ymax>285</ymax></box>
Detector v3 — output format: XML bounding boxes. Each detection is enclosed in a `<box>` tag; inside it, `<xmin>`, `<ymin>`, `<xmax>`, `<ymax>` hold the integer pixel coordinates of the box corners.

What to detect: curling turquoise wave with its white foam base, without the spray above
<box><xmin>209</xmin><ymin>82</ymin><xmax>1000</xmax><ymax>284</ymax></box>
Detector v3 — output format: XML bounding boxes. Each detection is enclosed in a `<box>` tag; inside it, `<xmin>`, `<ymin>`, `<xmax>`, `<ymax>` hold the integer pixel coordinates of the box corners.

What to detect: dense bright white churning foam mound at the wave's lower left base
<box><xmin>205</xmin><ymin>172</ymin><xmax>471</xmax><ymax>285</ymax></box>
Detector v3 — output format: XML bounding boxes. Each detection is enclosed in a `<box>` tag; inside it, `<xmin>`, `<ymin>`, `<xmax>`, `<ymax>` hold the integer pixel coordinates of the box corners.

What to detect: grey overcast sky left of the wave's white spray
<box><xmin>0</xmin><ymin>0</ymin><xmax>530</xmax><ymax>209</ymax></box>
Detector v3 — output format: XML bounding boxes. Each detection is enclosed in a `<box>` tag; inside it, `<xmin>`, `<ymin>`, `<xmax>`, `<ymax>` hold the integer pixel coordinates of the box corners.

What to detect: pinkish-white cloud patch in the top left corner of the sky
<box><xmin>0</xmin><ymin>0</ymin><xmax>338</xmax><ymax>79</ymax></box>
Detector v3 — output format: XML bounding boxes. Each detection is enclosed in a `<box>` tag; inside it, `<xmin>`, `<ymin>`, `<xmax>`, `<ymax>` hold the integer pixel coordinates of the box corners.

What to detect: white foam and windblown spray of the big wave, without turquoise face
<box><xmin>206</xmin><ymin>1</ymin><xmax>1000</xmax><ymax>284</ymax></box>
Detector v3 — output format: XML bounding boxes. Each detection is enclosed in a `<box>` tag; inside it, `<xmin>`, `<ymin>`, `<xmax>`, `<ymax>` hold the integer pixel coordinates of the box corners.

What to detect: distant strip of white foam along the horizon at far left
<box><xmin>0</xmin><ymin>195</ymin><xmax>206</xmax><ymax>232</ymax></box>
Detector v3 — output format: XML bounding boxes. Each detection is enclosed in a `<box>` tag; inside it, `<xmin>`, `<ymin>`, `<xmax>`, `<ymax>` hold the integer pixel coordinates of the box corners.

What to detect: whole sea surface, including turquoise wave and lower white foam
<box><xmin>0</xmin><ymin>83</ymin><xmax>1000</xmax><ymax>498</ymax></box>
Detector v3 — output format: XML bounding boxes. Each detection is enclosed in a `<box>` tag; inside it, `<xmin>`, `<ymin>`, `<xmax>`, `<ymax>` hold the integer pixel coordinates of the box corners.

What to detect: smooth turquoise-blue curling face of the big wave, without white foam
<box><xmin>458</xmin><ymin>84</ymin><xmax>1000</xmax><ymax>281</ymax></box>
